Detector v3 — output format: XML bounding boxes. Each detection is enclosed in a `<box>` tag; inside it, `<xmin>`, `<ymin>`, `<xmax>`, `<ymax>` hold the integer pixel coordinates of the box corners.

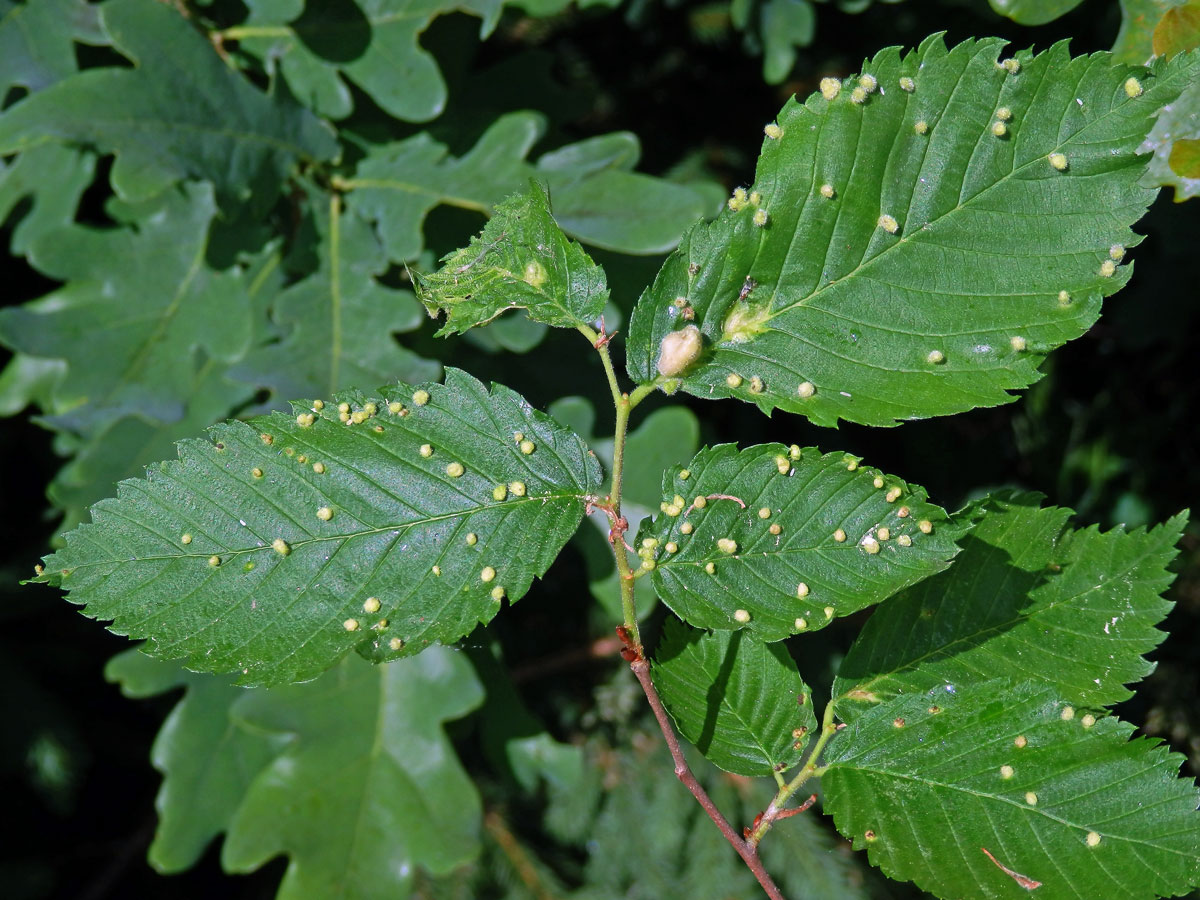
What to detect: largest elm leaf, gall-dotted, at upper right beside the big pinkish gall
<box><xmin>629</xmin><ymin>36</ymin><xmax>1200</xmax><ymax>425</ymax></box>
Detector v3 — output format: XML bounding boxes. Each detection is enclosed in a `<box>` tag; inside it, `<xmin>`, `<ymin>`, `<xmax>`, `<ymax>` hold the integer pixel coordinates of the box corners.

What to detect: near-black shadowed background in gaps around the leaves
<box><xmin>0</xmin><ymin>0</ymin><xmax>1200</xmax><ymax>900</ymax></box>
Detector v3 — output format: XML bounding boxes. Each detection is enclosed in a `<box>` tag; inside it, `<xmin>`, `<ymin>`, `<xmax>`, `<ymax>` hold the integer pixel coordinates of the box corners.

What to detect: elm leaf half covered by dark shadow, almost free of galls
<box><xmin>833</xmin><ymin>494</ymin><xmax>1187</xmax><ymax>721</ymax></box>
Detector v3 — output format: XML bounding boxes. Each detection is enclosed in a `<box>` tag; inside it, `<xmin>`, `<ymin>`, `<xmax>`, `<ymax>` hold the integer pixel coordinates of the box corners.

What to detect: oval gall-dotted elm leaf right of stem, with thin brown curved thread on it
<box><xmin>637</xmin><ymin>444</ymin><xmax>958</xmax><ymax>641</ymax></box>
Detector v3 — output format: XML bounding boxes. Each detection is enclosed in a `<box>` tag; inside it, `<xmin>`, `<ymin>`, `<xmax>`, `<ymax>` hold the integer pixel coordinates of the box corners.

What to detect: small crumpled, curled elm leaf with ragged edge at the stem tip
<box><xmin>415</xmin><ymin>181</ymin><xmax>608</xmax><ymax>336</ymax></box>
